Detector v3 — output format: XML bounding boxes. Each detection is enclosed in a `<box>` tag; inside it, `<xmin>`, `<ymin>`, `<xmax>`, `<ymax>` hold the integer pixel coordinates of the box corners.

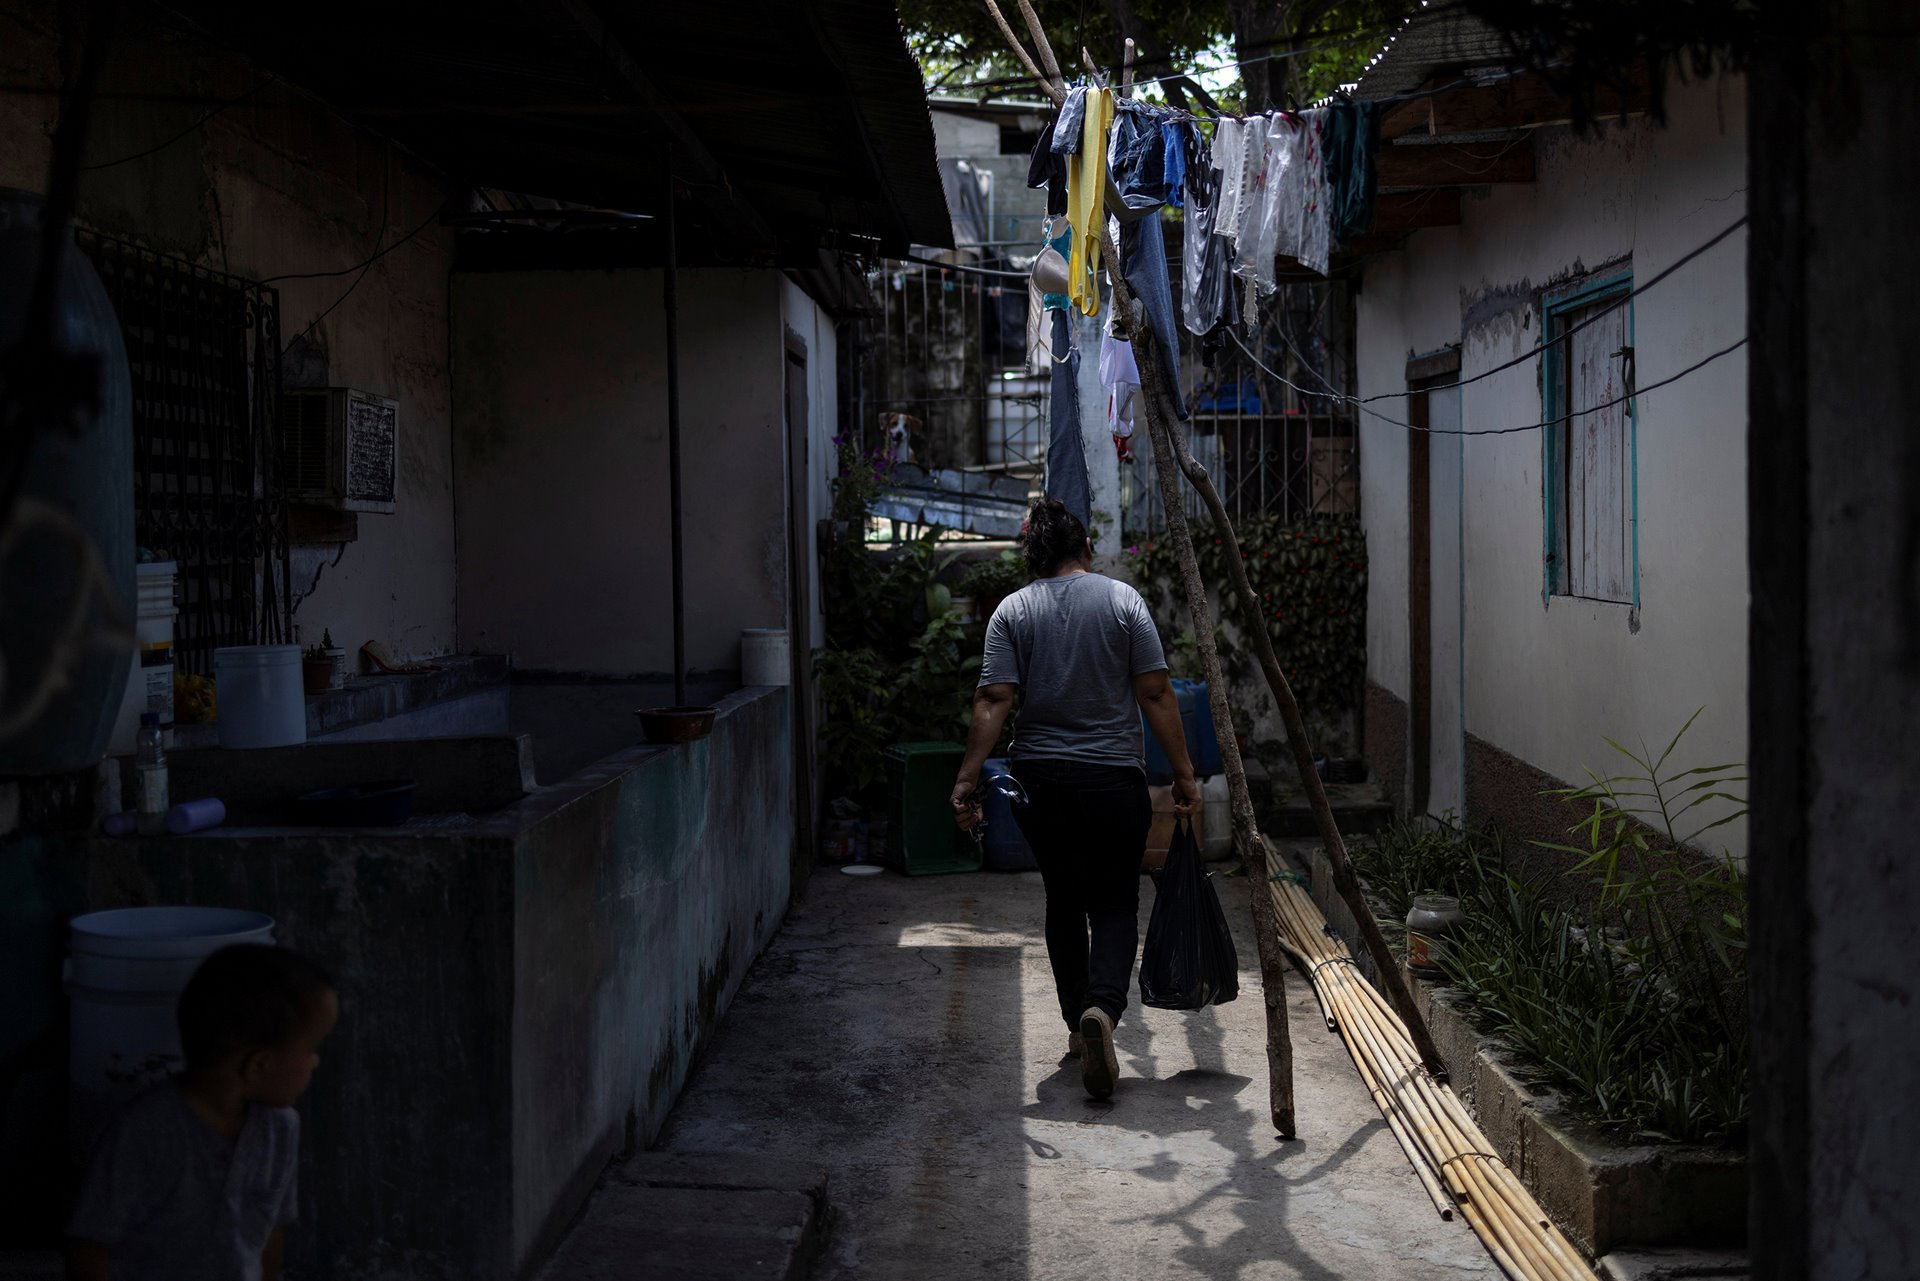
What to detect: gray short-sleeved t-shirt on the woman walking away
<box><xmin>979</xmin><ymin>574</ymin><xmax>1167</xmax><ymax>766</ymax></box>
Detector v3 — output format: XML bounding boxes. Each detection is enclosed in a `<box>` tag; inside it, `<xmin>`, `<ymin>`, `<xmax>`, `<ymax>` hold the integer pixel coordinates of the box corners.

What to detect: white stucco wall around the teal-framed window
<box><xmin>1357</xmin><ymin>70</ymin><xmax>1747</xmax><ymax>851</ymax></box>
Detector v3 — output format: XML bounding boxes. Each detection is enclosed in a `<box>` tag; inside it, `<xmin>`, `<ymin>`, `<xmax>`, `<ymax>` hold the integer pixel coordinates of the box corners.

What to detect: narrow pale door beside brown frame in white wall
<box><xmin>1427</xmin><ymin>388</ymin><xmax>1467</xmax><ymax>816</ymax></box>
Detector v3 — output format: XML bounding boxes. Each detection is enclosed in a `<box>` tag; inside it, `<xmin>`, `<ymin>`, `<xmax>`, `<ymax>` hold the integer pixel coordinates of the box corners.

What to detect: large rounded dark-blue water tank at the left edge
<box><xmin>0</xmin><ymin>188</ymin><xmax>134</xmax><ymax>774</ymax></box>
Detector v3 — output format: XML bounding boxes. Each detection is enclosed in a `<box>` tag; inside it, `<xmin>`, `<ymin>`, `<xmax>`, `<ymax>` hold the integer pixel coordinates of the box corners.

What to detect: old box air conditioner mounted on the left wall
<box><xmin>280</xmin><ymin>386</ymin><xmax>399</xmax><ymax>511</ymax></box>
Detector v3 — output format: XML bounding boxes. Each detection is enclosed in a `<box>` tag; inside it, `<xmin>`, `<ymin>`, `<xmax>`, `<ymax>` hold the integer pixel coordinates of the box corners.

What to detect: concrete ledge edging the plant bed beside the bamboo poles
<box><xmin>1286</xmin><ymin>843</ymin><xmax>1747</xmax><ymax>1252</ymax></box>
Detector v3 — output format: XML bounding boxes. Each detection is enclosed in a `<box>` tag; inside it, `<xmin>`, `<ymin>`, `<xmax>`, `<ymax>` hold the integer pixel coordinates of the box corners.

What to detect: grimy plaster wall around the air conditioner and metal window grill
<box><xmin>0</xmin><ymin>0</ymin><xmax>453</xmax><ymax>657</ymax></box>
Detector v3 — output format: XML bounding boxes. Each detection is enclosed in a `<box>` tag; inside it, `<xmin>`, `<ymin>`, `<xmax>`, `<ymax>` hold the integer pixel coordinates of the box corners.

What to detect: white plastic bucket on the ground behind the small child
<box><xmin>67</xmin><ymin>906</ymin><xmax>273</xmax><ymax>1154</ymax></box>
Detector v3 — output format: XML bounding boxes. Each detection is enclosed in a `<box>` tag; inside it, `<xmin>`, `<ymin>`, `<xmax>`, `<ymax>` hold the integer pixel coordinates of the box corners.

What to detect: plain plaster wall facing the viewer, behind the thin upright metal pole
<box><xmin>451</xmin><ymin>271</ymin><xmax>787</xmax><ymax>674</ymax></box>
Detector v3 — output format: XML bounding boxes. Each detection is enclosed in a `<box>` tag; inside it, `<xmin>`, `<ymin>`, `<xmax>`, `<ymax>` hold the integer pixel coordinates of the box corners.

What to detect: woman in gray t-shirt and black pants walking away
<box><xmin>952</xmin><ymin>497</ymin><xmax>1200</xmax><ymax>1099</ymax></box>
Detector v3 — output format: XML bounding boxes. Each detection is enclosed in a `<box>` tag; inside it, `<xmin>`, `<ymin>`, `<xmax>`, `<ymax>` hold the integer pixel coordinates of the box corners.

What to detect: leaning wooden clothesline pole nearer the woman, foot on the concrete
<box><xmin>985</xmin><ymin>0</ymin><xmax>1296</xmax><ymax>1139</ymax></box>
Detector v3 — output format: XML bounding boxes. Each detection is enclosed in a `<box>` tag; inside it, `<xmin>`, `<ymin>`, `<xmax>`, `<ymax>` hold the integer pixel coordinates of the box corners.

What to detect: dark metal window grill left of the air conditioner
<box><xmin>77</xmin><ymin>230</ymin><xmax>292</xmax><ymax>674</ymax></box>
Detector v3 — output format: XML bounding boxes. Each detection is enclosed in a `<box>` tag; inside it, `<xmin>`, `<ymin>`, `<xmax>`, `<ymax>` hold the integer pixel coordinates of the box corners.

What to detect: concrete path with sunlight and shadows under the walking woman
<box><xmin>657</xmin><ymin>870</ymin><xmax>1498</xmax><ymax>1281</ymax></box>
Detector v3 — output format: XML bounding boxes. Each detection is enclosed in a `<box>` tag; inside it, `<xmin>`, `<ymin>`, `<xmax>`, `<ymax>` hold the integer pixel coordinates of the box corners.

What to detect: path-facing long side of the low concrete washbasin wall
<box><xmin>513</xmin><ymin>689</ymin><xmax>793</xmax><ymax>1268</ymax></box>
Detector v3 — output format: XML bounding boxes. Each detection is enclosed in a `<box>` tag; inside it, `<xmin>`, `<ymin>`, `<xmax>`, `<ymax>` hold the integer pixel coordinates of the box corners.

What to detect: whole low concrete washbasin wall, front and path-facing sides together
<box><xmin>56</xmin><ymin>689</ymin><xmax>793</xmax><ymax>1281</ymax></box>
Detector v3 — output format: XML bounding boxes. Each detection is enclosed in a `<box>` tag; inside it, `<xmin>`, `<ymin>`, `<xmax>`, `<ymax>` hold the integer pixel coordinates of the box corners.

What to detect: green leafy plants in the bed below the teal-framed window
<box><xmin>1354</xmin><ymin>713</ymin><xmax>1747</xmax><ymax>1143</ymax></box>
